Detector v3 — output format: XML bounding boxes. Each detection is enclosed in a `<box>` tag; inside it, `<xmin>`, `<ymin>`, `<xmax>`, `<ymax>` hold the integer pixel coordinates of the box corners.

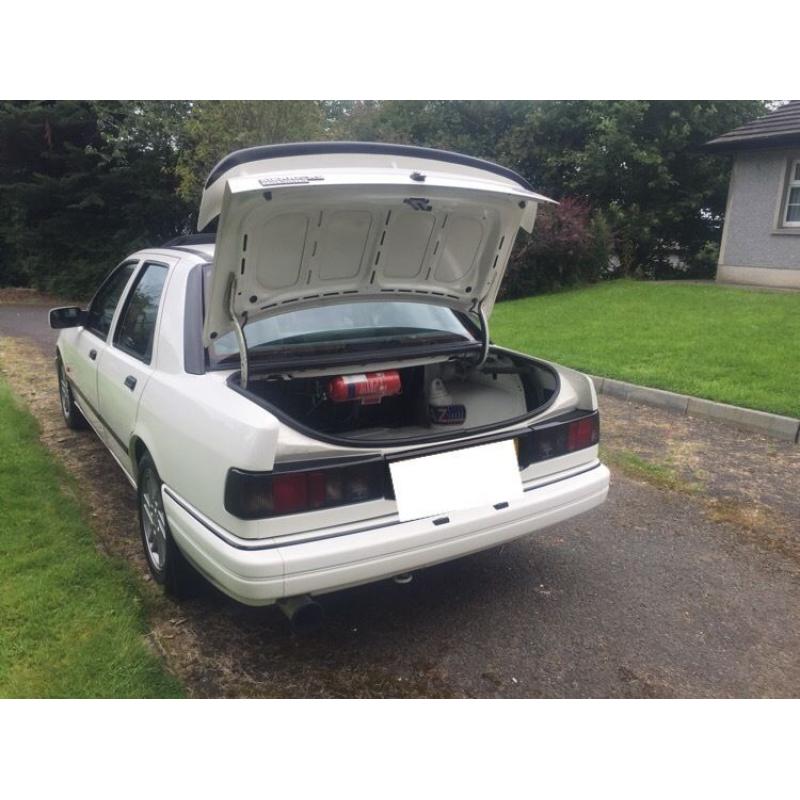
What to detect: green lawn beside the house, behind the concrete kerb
<box><xmin>491</xmin><ymin>281</ymin><xmax>800</xmax><ymax>417</ymax></box>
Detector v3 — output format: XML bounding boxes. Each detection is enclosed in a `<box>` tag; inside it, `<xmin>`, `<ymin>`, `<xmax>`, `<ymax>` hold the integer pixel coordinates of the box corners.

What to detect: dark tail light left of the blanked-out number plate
<box><xmin>225</xmin><ymin>459</ymin><xmax>386</xmax><ymax>519</ymax></box>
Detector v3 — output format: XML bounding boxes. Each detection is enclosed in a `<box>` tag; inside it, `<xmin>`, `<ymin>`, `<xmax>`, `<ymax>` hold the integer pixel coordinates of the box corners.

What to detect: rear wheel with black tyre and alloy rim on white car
<box><xmin>138</xmin><ymin>453</ymin><xmax>197</xmax><ymax>599</ymax></box>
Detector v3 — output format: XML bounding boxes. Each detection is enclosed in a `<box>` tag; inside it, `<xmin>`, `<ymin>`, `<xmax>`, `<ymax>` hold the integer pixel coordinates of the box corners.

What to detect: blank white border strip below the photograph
<box><xmin>0</xmin><ymin>700</ymin><xmax>797</xmax><ymax>800</ymax></box>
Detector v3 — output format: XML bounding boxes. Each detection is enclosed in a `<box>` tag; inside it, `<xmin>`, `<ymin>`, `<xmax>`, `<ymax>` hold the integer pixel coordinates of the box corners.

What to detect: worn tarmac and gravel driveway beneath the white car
<box><xmin>0</xmin><ymin>305</ymin><xmax>800</xmax><ymax>697</ymax></box>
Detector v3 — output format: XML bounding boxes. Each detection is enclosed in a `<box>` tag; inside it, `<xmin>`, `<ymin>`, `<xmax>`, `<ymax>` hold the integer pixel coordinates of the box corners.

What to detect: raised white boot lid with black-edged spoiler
<box><xmin>198</xmin><ymin>142</ymin><xmax>551</xmax><ymax>345</ymax></box>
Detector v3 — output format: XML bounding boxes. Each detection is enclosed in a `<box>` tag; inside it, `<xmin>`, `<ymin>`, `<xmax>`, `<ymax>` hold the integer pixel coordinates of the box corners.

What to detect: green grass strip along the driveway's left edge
<box><xmin>0</xmin><ymin>380</ymin><xmax>184</xmax><ymax>697</ymax></box>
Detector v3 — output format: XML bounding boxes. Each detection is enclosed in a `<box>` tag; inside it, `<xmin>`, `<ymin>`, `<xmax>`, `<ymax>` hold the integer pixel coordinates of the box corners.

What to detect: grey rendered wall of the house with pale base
<box><xmin>717</xmin><ymin>149</ymin><xmax>800</xmax><ymax>288</ymax></box>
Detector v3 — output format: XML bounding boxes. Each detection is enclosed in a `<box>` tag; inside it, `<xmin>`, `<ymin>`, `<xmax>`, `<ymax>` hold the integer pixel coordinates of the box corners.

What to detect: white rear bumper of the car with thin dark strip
<box><xmin>164</xmin><ymin>462</ymin><xmax>609</xmax><ymax>605</ymax></box>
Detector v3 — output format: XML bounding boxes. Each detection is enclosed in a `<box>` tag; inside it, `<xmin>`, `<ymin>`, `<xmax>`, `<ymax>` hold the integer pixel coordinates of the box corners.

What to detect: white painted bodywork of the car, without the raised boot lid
<box><xmin>57</xmin><ymin>144</ymin><xmax>608</xmax><ymax>605</ymax></box>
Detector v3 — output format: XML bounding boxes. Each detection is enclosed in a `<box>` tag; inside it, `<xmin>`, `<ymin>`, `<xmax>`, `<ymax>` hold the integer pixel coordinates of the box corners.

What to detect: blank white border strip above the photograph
<box><xmin>0</xmin><ymin>0</ymin><xmax>797</xmax><ymax>99</ymax></box>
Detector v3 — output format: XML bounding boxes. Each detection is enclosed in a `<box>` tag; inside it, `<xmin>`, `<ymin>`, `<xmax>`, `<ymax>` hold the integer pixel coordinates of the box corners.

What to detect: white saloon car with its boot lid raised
<box><xmin>50</xmin><ymin>142</ymin><xmax>609</xmax><ymax>625</ymax></box>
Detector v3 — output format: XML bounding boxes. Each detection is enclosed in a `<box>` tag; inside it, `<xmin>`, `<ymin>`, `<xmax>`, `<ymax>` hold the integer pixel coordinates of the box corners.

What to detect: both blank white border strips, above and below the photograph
<box><xmin>0</xmin><ymin>0</ymin><xmax>798</xmax><ymax>800</ymax></box>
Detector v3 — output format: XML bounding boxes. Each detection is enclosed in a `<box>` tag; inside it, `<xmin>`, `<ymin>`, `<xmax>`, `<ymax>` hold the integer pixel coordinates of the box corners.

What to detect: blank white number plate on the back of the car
<box><xmin>389</xmin><ymin>439</ymin><xmax>522</xmax><ymax>522</ymax></box>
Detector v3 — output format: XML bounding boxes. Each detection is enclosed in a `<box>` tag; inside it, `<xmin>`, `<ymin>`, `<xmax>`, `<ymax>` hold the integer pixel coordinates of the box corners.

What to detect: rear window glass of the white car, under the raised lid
<box><xmin>210</xmin><ymin>301</ymin><xmax>474</xmax><ymax>361</ymax></box>
